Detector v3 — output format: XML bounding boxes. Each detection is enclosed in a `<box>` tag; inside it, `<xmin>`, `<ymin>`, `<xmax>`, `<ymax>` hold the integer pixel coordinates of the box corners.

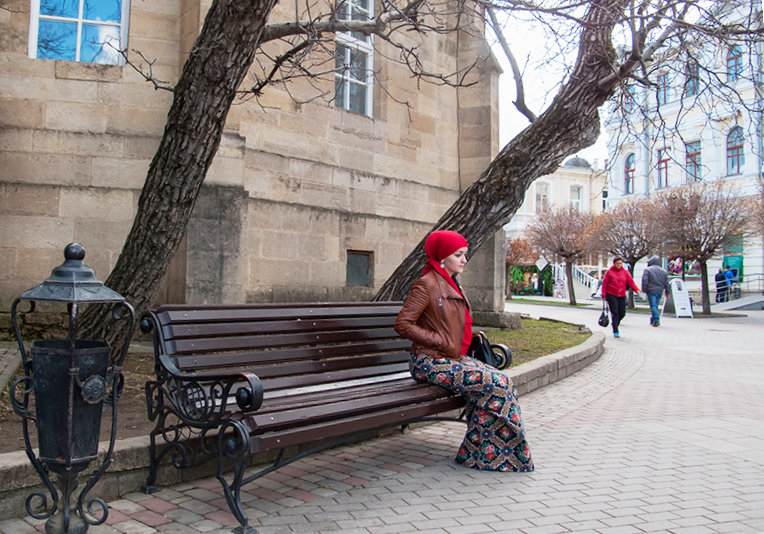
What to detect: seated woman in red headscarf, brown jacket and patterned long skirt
<box><xmin>395</xmin><ymin>231</ymin><xmax>533</xmax><ymax>471</ymax></box>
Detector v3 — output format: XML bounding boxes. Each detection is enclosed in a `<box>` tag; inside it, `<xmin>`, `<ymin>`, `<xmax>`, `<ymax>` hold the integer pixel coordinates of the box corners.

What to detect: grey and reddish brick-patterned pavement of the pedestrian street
<box><xmin>0</xmin><ymin>305</ymin><xmax>764</xmax><ymax>534</ymax></box>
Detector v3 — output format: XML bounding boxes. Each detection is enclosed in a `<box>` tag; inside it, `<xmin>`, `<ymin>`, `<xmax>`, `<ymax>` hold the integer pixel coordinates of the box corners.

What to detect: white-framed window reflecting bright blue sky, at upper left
<box><xmin>29</xmin><ymin>0</ymin><xmax>130</xmax><ymax>65</ymax></box>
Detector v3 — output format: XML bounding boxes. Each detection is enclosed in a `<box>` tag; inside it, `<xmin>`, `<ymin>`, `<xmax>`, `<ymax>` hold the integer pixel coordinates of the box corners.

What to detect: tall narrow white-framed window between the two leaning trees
<box><xmin>334</xmin><ymin>0</ymin><xmax>374</xmax><ymax>117</ymax></box>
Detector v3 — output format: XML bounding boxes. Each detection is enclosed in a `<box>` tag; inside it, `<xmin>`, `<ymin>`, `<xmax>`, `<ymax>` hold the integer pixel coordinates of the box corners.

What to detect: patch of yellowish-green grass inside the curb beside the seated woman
<box><xmin>485</xmin><ymin>318</ymin><xmax>592</xmax><ymax>367</ymax></box>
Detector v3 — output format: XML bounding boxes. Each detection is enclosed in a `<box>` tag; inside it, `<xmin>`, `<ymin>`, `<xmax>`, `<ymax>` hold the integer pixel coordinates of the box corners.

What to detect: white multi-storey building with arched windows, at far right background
<box><xmin>605</xmin><ymin>1</ymin><xmax>764</xmax><ymax>287</ymax></box>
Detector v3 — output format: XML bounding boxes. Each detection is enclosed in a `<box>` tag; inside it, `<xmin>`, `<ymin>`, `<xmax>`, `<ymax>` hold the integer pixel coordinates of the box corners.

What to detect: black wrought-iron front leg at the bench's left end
<box><xmin>217</xmin><ymin>421</ymin><xmax>255</xmax><ymax>534</ymax></box>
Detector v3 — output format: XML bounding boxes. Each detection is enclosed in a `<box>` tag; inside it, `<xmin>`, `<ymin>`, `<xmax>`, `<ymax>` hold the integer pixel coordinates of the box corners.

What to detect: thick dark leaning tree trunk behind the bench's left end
<box><xmin>80</xmin><ymin>0</ymin><xmax>276</xmax><ymax>354</ymax></box>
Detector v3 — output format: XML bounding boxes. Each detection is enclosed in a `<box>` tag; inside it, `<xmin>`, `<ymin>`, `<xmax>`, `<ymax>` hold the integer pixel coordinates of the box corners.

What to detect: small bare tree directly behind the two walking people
<box><xmin>592</xmin><ymin>199</ymin><xmax>663</xmax><ymax>308</ymax></box>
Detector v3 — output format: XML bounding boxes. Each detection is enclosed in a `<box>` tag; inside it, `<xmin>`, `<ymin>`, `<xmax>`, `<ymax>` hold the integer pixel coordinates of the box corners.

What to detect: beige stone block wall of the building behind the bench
<box><xmin>0</xmin><ymin>0</ymin><xmax>503</xmax><ymax>312</ymax></box>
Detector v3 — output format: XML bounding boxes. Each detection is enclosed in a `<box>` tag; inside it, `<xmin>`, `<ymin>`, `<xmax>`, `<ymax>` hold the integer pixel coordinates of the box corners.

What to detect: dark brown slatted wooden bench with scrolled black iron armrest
<box><xmin>141</xmin><ymin>302</ymin><xmax>484</xmax><ymax>532</ymax></box>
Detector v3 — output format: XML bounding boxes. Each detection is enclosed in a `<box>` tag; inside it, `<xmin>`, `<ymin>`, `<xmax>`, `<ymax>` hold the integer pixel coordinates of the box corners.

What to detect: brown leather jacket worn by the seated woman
<box><xmin>395</xmin><ymin>271</ymin><xmax>470</xmax><ymax>360</ymax></box>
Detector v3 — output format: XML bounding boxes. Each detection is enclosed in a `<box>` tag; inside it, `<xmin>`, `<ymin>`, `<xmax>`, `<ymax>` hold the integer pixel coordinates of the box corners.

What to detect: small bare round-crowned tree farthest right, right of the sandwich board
<box><xmin>656</xmin><ymin>180</ymin><xmax>758</xmax><ymax>315</ymax></box>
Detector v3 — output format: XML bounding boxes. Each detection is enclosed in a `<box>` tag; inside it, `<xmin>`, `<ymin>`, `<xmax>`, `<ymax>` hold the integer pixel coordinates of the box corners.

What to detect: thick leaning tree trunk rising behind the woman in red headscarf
<box><xmin>374</xmin><ymin>1</ymin><xmax>625</xmax><ymax>300</ymax></box>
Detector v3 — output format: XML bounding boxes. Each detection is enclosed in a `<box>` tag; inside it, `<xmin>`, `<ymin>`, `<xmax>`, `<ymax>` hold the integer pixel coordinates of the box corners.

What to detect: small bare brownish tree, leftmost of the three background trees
<box><xmin>527</xmin><ymin>207</ymin><xmax>594</xmax><ymax>306</ymax></box>
